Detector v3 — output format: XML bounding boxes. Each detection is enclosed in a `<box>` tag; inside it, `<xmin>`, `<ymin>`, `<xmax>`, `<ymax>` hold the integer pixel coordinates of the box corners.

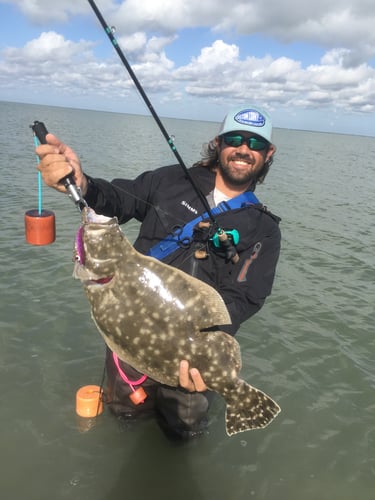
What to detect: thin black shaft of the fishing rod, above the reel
<box><xmin>88</xmin><ymin>0</ymin><xmax>219</xmax><ymax>229</ymax></box>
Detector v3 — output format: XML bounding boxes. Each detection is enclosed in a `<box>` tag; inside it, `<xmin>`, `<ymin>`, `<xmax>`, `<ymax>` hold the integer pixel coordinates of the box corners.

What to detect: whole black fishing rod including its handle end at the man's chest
<box><xmin>88</xmin><ymin>0</ymin><xmax>239</xmax><ymax>264</ymax></box>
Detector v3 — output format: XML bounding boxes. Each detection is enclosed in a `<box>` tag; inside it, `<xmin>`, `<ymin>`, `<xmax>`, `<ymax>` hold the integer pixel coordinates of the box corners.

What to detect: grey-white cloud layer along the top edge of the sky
<box><xmin>4</xmin><ymin>0</ymin><xmax>375</xmax><ymax>66</ymax></box>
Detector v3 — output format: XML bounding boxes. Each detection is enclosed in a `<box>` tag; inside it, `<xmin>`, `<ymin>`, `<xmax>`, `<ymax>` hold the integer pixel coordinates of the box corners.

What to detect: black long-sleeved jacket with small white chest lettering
<box><xmin>85</xmin><ymin>165</ymin><xmax>280</xmax><ymax>335</ymax></box>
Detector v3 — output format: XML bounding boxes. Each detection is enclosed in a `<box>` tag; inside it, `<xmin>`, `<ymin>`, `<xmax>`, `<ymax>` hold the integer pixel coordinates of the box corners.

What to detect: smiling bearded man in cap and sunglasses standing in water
<box><xmin>36</xmin><ymin>105</ymin><xmax>280</xmax><ymax>438</ymax></box>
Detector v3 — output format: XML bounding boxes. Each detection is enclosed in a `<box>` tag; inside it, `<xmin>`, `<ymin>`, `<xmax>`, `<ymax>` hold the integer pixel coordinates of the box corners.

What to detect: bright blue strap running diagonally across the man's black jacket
<box><xmin>147</xmin><ymin>191</ymin><xmax>260</xmax><ymax>260</ymax></box>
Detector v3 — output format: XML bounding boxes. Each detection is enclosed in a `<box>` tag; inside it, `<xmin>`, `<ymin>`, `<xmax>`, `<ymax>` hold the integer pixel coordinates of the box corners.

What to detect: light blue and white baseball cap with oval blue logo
<box><xmin>218</xmin><ymin>105</ymin><xmax>272</xmax><ymax>142</ymax></box>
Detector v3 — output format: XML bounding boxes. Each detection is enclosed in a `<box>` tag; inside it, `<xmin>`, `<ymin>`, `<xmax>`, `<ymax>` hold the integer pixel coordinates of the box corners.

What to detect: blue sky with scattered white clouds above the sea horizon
<box><xmin>0</xmin><ymin>0</ymin><xmax>375</xmax><ymax>136</ymax></box>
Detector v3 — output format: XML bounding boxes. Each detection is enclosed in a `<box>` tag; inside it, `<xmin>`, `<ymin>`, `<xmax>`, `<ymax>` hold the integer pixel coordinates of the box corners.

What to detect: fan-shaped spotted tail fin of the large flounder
<box><xmin>225</xmin><ymin>379</ymin><xmax>280</xmax><ymax>436</ymax></box>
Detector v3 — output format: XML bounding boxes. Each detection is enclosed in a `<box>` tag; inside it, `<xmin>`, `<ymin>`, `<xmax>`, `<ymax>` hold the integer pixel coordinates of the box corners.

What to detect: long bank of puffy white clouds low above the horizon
<box><xmin>0</xmin><ymin>32</ymin><xmax>375</xmax><ymax>112</ymax></box>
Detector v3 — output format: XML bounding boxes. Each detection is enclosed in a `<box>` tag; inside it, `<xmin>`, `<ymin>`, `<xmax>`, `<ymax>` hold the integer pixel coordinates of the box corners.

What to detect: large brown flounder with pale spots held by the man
<box><xmin>74</xmin><ymin>209</ymin><xmax>280</xmax><ymax>436</ymax></box>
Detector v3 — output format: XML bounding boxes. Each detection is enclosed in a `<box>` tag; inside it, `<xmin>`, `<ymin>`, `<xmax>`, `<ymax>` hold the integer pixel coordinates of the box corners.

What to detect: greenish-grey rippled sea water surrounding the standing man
<box><xmin>0</xmin><ymin>102</ymin><xmax>375</xmax><ymax>500</ymax></box>
